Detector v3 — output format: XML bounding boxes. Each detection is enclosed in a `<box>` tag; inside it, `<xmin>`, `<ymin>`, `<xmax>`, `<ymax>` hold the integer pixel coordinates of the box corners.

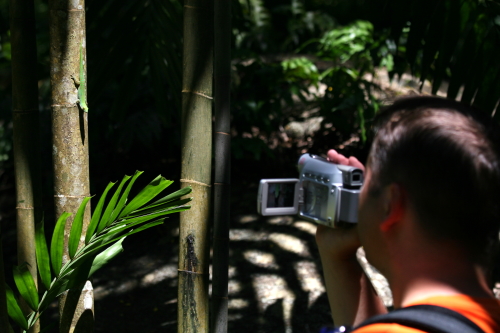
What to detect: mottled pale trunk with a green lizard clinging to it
<box><xmin>49</xmin><ymin>0</ymin><xmax>94</xmax><ymax>333</ymax></box>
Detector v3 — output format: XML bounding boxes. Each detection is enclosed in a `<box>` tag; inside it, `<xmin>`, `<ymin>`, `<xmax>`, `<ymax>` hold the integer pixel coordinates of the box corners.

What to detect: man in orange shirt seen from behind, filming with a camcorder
<box><xmin>316</xmin><ymin>97</ymin><xmax>500</xmax><ymax>333</ymax></box>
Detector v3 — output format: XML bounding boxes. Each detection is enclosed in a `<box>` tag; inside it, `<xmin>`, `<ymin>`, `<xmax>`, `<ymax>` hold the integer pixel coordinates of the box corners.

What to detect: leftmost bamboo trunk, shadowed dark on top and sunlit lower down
<box><xmin>10</xmin><ymin>0</ymin><xmax>42</xmax><ymax>332</ymax></box>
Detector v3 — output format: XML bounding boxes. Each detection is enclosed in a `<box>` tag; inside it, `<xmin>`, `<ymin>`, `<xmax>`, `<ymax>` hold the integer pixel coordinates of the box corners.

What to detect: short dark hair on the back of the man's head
<box><xmin>368</xmin><ymin>97</ymin><xmax>500</xmax><ymax>261</ymax></box>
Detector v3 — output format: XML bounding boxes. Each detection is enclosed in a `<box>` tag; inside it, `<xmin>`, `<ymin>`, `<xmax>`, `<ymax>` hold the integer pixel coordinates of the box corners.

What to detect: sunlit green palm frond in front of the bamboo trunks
<box><xmin>6</xmin><ymin>171</ymin><xmax>192</xmax><ymax>332</ymax></box>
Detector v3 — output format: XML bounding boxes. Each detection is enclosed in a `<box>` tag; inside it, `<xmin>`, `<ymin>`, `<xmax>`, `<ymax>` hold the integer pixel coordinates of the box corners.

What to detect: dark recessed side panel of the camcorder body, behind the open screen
<box><xmin>302</xmin><ymin>180</ymin><xmax>328</xmax><ymax>221</ymax></box>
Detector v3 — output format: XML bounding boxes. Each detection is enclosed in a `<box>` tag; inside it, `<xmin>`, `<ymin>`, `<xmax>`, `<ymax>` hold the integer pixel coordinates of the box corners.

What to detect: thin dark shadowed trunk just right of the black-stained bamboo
<box><xmin>211</xmin><ymin>0</ymin><xmax>231</xmax><ymax>333</ymax></box>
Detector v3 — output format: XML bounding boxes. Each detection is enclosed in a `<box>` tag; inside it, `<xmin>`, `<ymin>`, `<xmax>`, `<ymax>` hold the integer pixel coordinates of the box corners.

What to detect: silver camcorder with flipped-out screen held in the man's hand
<box><xmin>257</xmin><ymin>154</ymin><xmax>363</xmax><ymax>228</ymax></box>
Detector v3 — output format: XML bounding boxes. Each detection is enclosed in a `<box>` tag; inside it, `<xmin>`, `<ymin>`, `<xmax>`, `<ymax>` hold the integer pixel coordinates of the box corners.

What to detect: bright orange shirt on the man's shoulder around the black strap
<box><xmin>353</xmin><ymin>295</ymin><xmax>500</xmax><ymax>333</ymax></box>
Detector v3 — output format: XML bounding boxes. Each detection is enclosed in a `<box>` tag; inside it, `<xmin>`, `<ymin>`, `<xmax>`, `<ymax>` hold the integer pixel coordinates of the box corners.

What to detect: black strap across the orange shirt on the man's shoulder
<box><xmin>355</xmin><ymin>305</ymin><xmax>484</xmax><ymax>333</ymax></box>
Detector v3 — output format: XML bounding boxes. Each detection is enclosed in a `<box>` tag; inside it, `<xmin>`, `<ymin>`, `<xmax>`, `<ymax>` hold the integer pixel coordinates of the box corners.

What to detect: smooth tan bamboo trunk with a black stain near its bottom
<box><xmin>178</xmin><ymin>0</ymin><xmax>213</xmax><ymax>333</ymax></box>
